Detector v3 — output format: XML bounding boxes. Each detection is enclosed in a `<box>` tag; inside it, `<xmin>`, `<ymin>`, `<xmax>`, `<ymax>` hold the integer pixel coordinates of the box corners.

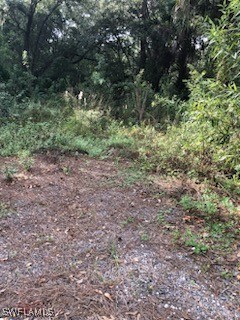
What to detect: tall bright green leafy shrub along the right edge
<box><xmin>174</xmin><ymin>0</ymin><xmax>240</xmax><ymax>175</ymax></box>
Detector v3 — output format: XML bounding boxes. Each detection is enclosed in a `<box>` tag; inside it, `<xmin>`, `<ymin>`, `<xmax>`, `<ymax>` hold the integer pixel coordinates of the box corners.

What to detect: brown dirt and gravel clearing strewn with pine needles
<box><xmin>0</xmin><ymin>156</ymin><xmax>240</xmax><ymax>320</ymax></box>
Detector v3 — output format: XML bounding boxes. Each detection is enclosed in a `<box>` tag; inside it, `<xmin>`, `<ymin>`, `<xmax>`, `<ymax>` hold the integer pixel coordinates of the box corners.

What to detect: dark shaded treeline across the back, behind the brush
<box><xmin>0</xmin><ymin>0</ymin><xmax>223</xmax><ymax>99</ymax></box>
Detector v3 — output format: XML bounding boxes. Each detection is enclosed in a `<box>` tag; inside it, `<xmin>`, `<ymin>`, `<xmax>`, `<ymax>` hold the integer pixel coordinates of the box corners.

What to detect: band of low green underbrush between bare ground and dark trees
<box><xmin>0</xmin><ymin>99</ymin><xmax>240</xmax><ymax>196</ymax></box>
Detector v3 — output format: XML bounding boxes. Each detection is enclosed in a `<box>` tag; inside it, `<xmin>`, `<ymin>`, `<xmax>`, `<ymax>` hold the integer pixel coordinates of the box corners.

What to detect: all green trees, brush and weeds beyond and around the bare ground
<box><xmin>0</xmin><ymin>0</ymin><xmax>240</xmax><ymax>238</ymax></box>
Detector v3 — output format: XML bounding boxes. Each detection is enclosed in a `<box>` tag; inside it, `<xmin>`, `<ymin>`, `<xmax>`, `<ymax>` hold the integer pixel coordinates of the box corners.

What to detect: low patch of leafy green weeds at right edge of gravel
<box><xmin>176</xmin><ymin>190</ymin><xmax>240</xmax><ymax>253</ymax></box>
